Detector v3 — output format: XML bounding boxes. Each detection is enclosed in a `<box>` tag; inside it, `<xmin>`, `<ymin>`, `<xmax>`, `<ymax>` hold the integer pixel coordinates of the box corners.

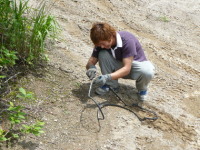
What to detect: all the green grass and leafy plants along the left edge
<box><xmin>0</xmin><ymin>0</ymin><xmax>59</xmax><ymax>147</ymax></box>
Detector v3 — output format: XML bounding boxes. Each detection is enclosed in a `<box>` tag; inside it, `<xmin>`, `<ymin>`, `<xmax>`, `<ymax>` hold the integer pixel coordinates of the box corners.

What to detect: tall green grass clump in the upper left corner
<box><xmin>0</xmin><ymin>0</ymin><xmax>58</xmax><ymax>65</ymax></box>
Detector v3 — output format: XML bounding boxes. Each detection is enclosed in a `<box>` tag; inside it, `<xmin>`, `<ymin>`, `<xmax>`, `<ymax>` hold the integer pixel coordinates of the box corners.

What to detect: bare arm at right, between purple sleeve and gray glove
<box><xmin>110</xmin><ymin>57</ymin><xmax>133</xmax><ymax>80</ymax></box>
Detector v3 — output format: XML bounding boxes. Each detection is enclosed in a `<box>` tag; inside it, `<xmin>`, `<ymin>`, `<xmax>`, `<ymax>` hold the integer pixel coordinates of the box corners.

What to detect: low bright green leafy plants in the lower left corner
<box><xmin>0</xmin><ymin>88</ymin><xmax>45</xmax><ymax>142</ymax></box>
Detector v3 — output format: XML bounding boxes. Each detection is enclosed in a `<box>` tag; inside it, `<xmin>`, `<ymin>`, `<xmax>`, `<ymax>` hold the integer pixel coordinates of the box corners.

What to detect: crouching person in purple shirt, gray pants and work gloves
<box><xmin>86</xmin><ymin>23</ymin><xmax>154</xmax><ymax>101</ymax></box>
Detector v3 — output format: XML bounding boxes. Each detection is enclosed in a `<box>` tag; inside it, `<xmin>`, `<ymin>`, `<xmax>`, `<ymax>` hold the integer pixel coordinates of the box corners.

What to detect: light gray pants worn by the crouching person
<box><xmin>98</xmin><ymin>50</ymin><xmax>155</xmax><ymax>91</ymax></box>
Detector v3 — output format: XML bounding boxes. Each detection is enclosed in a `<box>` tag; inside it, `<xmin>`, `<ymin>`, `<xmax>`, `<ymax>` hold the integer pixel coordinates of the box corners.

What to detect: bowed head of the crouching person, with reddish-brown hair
<box><xmin>90</xmin><ymin>23</ymin><xmax>116</xmax><ymax>49</ymax></box>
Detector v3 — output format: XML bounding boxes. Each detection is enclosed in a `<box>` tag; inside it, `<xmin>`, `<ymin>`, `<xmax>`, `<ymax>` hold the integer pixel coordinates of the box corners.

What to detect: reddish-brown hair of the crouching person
<box><xmin>90</xmin><ymin>22</ymin><xmax>116</xmax><ymax>44</ymax></box>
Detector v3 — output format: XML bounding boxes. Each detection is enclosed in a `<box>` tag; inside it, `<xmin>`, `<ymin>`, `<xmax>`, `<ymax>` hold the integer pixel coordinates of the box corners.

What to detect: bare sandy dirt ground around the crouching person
<box><xmin>0</xmin><ymin>0</ymin><xmax>200</xmax><ymax>150</ymax></box>
